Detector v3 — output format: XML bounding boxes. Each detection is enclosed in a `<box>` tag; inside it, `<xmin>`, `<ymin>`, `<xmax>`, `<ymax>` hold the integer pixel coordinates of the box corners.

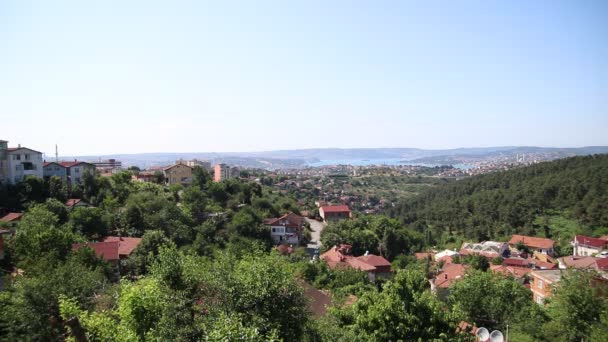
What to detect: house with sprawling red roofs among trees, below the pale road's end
<box><xmin>320</xmin><ymin>244</ymin><xmax>391</xmax><ymax>282</ymax></box>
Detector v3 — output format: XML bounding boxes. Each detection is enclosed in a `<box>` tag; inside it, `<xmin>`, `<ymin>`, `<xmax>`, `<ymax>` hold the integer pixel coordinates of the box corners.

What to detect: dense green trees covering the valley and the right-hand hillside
<box><xmin>0</xmin><ymin>156</ymin><xmax>608</xmax><ymax>342</ymax></box>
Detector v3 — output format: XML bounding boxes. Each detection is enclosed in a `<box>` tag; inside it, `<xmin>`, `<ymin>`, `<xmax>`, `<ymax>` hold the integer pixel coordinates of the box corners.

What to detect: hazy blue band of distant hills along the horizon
<box><xmin>71</xmin><ymin>146</ymin><xmax>608</xmax><ymax>168</ymax></box>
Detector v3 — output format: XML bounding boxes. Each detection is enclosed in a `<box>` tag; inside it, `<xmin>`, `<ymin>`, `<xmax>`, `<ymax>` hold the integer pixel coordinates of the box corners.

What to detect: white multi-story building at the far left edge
<box><xmin>0</xmin><ymin>140</ymin><xmax>43</xmax><ymax>184</ymax></box>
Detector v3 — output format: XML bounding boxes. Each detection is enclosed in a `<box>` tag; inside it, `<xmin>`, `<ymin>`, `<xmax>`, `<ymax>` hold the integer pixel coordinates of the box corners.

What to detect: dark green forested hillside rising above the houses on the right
<box><xmin>391</xmin><ymin>155</ymin><xmax>608</xmax><ymax>246</ymax></box>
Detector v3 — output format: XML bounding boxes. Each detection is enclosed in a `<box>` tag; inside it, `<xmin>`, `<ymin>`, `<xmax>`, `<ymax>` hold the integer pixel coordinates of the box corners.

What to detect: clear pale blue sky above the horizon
<box><xmin>0</xmin><ymin>0</ymin><xmax>608</xmax><ymax>155</ymax></box>
